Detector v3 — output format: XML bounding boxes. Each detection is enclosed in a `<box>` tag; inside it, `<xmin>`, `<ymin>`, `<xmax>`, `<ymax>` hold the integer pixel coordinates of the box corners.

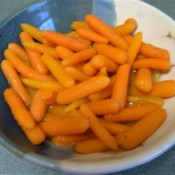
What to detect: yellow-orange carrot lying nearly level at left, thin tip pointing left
<box><xmin>22</xmin><ymin>78</ymin><xmax>63</xmax><ymax>92</ymax></box>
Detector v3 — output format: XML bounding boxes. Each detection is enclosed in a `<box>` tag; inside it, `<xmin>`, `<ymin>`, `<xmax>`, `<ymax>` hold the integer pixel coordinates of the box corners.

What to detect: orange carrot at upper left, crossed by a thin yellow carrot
<box><xmin>20</xmin><ymin>32</ymin><xmax>48</xmax><ymax>74</ymax></box>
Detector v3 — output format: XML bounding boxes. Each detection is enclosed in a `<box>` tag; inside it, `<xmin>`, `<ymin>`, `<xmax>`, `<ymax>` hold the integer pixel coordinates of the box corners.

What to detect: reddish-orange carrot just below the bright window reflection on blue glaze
<box><xmin>42</xmin><ymin>30</ymin><xmax>88</xmax><ymax>51</ymax></box>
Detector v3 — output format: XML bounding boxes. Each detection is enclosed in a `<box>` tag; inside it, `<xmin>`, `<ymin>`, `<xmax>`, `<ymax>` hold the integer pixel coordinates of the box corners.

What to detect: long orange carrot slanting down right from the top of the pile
<box><xmin>85</xmin><ymin>14</ymin><xmax>128</xmax><ymax>50</ymax></box>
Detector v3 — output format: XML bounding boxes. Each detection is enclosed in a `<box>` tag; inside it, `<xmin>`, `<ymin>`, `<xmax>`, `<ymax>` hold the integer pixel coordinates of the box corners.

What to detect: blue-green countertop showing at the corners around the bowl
<box><xmin>0</xmin><ymin>0</ymin><xmax>175</xmax><ymax>175</ymax></box>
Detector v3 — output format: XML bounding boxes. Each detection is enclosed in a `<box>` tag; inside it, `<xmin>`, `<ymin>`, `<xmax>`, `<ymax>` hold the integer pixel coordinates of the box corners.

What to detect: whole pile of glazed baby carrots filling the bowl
<box><xmin>1</xmin><ymin>14</ymin><xmax>175</xmax><ymax>154</ymax></box>
